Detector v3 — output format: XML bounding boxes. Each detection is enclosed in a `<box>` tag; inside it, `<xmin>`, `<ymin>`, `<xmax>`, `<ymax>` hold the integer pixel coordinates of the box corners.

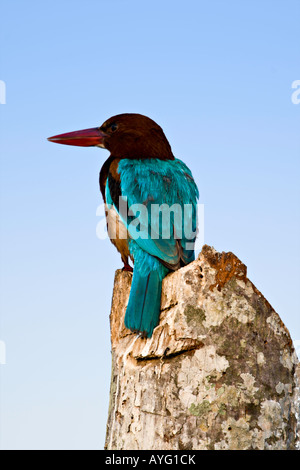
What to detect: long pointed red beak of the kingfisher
<box><xmin>48</xmin><ymin>127</ymin><xmax>107</xmax><ymax>147</ymax></box>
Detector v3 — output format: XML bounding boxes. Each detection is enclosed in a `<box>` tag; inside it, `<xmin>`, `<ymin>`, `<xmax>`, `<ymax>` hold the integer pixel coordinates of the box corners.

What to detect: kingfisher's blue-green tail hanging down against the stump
<box><xmin>125</xmin><ymin>269</ymin><xmax>162</xmax><ymax>338</ymax></box>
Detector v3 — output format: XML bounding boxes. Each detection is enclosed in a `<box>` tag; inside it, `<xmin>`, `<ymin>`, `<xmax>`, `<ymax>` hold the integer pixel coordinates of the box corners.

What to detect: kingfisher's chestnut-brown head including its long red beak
<box><xmin>48</xmin><ymin>113</ymin><xmax>174</xmax><ymax>160</ymax></box>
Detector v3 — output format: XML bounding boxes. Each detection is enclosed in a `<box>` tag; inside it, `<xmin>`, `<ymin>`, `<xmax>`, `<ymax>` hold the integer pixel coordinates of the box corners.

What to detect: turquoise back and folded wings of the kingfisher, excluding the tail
<box><xmin>106</xmin><ymin>159</ymin><xmax>199</xmax><ymax>269</ymax></box>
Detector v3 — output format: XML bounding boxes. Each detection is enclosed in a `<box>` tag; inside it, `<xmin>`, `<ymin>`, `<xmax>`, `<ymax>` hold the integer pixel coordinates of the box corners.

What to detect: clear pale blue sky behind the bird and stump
<box><xmin>0</xmin><ymin>0</ymin><xmax>300</xmax><ymax>449</ymax></box>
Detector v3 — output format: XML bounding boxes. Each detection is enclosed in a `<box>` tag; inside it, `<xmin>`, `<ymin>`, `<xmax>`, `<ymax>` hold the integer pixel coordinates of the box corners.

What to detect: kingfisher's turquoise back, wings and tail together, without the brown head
<box><xmin>106</xmin><ymin>159</ymin><xmax>199</xmax><ymax>337</ymax></box>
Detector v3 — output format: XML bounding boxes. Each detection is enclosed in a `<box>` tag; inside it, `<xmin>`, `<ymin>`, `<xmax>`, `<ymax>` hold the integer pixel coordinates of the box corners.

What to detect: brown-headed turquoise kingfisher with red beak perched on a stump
<box><xmin>48</xmin><ymin>113</ymin><xmax>199</xmax><ymax>338</ymax></box>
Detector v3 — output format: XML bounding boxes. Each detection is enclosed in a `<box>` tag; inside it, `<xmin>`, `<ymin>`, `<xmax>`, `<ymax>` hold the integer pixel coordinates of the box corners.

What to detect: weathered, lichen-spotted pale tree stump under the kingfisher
<box><xmin>105</xmin><ymin>245</ymin><xmax>299</xmax><ymax>450</ymax></box>
